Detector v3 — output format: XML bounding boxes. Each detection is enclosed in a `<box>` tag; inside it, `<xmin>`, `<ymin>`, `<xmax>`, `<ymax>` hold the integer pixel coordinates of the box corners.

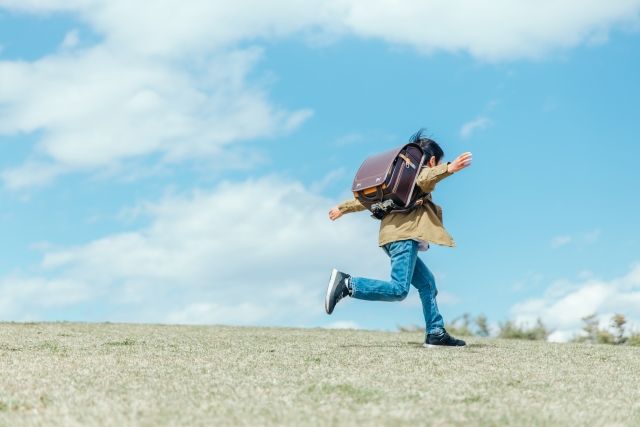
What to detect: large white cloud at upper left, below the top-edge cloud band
<box><xmin>0</xmin><ymin>47</ymin><xmax>311</xmax><ymax>188</ymax></box>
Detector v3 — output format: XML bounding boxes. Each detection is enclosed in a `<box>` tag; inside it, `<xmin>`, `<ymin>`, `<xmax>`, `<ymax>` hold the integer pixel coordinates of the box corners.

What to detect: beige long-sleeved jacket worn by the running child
<box><xmin>338</xmin><ymin>163</ymin><xmax>456</xmax><ymax>251</ymax></box>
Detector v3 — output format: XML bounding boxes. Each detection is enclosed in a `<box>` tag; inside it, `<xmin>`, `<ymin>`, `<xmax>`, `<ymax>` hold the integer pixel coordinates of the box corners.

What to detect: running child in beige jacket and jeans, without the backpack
<box><xmin>325</xmin><ymin>129</ymin><xmax>471</xmax><ymax>348</ymax></box>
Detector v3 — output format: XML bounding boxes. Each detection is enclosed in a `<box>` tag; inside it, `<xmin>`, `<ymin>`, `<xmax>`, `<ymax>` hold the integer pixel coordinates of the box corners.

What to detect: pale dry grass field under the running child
<box><xmin>0</xmin><ymin>323</ymin><xmax>640</xmax><ymax>427</ymax></box>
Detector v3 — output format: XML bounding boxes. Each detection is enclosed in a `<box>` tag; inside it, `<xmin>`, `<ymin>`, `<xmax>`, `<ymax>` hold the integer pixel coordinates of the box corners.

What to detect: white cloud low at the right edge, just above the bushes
<box><xmin>511</xmin><ymin>264</ymin><xmax>640</xmax><ymax>341</ymax></box>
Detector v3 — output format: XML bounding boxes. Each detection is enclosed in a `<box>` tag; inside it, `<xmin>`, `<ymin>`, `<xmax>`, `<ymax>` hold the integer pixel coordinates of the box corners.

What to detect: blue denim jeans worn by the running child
<box><xmin>350</xmin><ymin>240</ymin><xmax>444</xmax><ymax>334</ymax></box>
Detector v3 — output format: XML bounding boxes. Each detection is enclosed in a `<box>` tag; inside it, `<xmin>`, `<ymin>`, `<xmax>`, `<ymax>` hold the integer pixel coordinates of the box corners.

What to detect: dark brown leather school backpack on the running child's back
<box><xmin>351</xmin><ymin>143</ymin><xmax>426</xmax><ymax>219</ymax></box>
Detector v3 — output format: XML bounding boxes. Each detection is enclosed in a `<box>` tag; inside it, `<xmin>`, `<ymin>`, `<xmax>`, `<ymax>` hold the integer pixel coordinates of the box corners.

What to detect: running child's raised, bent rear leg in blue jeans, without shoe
<box><xmin>349</xmin><ymin>240</ymin><xmax>418</xmax><ymax>301</ymax></box>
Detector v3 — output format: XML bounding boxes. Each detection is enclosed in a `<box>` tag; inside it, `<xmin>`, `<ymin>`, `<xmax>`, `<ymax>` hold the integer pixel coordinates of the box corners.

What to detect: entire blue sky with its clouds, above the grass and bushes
<box><xmin>0</xmin><ymin>0</ymin><xmax>640</xmax><ymax>340</ymax></box>
